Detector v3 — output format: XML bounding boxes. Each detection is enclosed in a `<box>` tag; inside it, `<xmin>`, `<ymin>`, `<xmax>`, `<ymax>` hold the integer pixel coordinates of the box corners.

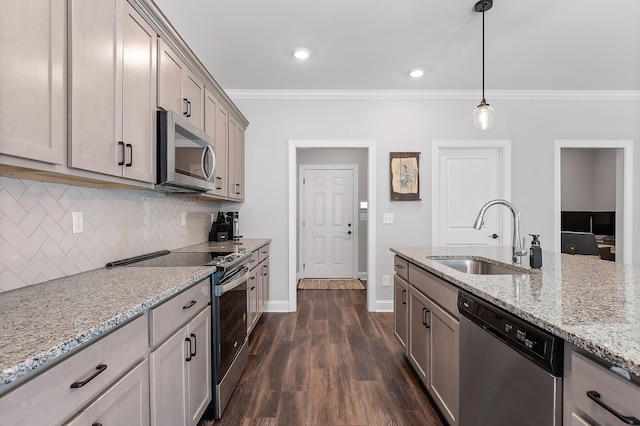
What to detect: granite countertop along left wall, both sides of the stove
<box><xmin>0</xmin><ymin>239</ymin><xmax>271</xmax><ymax>395</ymax></box>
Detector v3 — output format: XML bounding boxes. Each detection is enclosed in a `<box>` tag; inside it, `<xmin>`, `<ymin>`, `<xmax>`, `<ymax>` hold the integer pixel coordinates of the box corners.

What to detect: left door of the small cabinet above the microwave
<box><xmin>158</xmin><ymin>39</ymin><xmax>187</xmax><ymax>114</ymax></box>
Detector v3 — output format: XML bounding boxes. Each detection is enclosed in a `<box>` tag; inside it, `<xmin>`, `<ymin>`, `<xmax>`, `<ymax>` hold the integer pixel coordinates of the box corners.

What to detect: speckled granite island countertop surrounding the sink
<box><xmin>391</xmin><ymin>247</ymin><xmax>640</xmax><ymax>376</ymax></box>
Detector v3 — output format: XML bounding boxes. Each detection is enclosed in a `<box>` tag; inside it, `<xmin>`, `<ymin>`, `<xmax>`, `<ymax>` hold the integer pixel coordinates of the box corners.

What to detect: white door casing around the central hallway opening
<box><xmin>288</xmin><ymin>140</ymin><xmax>376</xmax><ymax>312</ymax></box>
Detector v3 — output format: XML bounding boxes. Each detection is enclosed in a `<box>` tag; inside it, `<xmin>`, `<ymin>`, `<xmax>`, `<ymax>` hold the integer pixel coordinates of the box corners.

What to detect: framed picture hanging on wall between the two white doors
<box><xmin>389</xmin><ymin>152</ymin><xmax>420</xmax><ymax>201</ymax></box>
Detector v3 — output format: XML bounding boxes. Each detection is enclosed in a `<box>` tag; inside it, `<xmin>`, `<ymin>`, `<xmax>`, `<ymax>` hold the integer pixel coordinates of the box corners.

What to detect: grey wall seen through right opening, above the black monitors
<box><xmin>561</xmin><ymin>148</ymin><xmax>616</xmax><ymax>211</ymax></box>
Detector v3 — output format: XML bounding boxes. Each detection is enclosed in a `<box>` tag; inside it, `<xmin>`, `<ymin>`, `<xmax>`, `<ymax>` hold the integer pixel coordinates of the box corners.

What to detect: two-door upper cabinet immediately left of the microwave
<box><xmin>69</xmin><ymin>0</ymin><xmax>157</xmax><ymax>183</ymax></box>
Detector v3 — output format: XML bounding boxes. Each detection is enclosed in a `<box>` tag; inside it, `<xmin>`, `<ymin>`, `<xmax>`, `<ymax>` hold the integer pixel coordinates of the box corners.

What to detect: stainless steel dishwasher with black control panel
<box><xmin>458</xmin><ymin>291</ymin><xmax>563</xmax><ymax>426</ymax></box>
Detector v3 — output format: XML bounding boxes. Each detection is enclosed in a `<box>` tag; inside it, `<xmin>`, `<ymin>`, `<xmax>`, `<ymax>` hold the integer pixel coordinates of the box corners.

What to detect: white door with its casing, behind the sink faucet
<box><xmin>432</xmin><ymin>140</ymin><xmax>512</xmax><ymax>247</ymax></box>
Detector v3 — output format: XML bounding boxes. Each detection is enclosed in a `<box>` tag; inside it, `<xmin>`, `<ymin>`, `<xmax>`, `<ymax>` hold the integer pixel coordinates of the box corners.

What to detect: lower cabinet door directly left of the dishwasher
<box><xmin>428</xmin><ymin>303</ymin><xmax>460</xmax><ymax>425</ymax></box>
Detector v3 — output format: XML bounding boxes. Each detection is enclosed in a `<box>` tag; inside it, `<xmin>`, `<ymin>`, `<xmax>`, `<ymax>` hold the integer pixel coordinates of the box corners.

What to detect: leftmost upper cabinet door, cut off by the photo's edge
<box><xmin>0</xmin><ymin>0</ymin><xmax>66</xmax><ymax>164</ymax></box>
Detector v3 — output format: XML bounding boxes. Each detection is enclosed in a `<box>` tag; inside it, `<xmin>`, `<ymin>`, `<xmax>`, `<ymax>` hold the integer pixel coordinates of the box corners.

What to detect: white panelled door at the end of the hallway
<box><xmin>301</xmin><ymin>168</ymin><xmax>357</xmax><ymax>278</ymax></box>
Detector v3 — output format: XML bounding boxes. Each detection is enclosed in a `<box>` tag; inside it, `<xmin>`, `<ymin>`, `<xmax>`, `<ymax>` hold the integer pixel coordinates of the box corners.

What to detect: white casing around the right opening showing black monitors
<box><xmin>554</xmin><ymin>140</ymin><xmax>633</xmax><ymax>264</ymax></box>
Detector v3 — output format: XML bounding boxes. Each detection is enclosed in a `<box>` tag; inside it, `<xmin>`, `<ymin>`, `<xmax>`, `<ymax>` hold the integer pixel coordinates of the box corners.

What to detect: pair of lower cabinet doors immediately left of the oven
<box><xmin>149</xmin><ymin>307</ymin><xmax>212</xmax><ymax>426</ymax></box>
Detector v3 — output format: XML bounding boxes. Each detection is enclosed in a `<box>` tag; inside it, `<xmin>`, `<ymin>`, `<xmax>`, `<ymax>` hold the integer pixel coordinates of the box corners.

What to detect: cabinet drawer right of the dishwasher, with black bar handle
<box><xmin>571</xmin><ymin>352</ymin><xmax>640</xmax><ymax>425</ymax></box>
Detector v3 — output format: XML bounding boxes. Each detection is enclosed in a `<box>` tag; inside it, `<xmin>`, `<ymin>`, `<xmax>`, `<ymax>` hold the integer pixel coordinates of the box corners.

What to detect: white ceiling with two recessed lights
<box><xmin>155</xmin><ymin>0</ymin><xmax>640</xmax><ymax>91</ymax></box>
